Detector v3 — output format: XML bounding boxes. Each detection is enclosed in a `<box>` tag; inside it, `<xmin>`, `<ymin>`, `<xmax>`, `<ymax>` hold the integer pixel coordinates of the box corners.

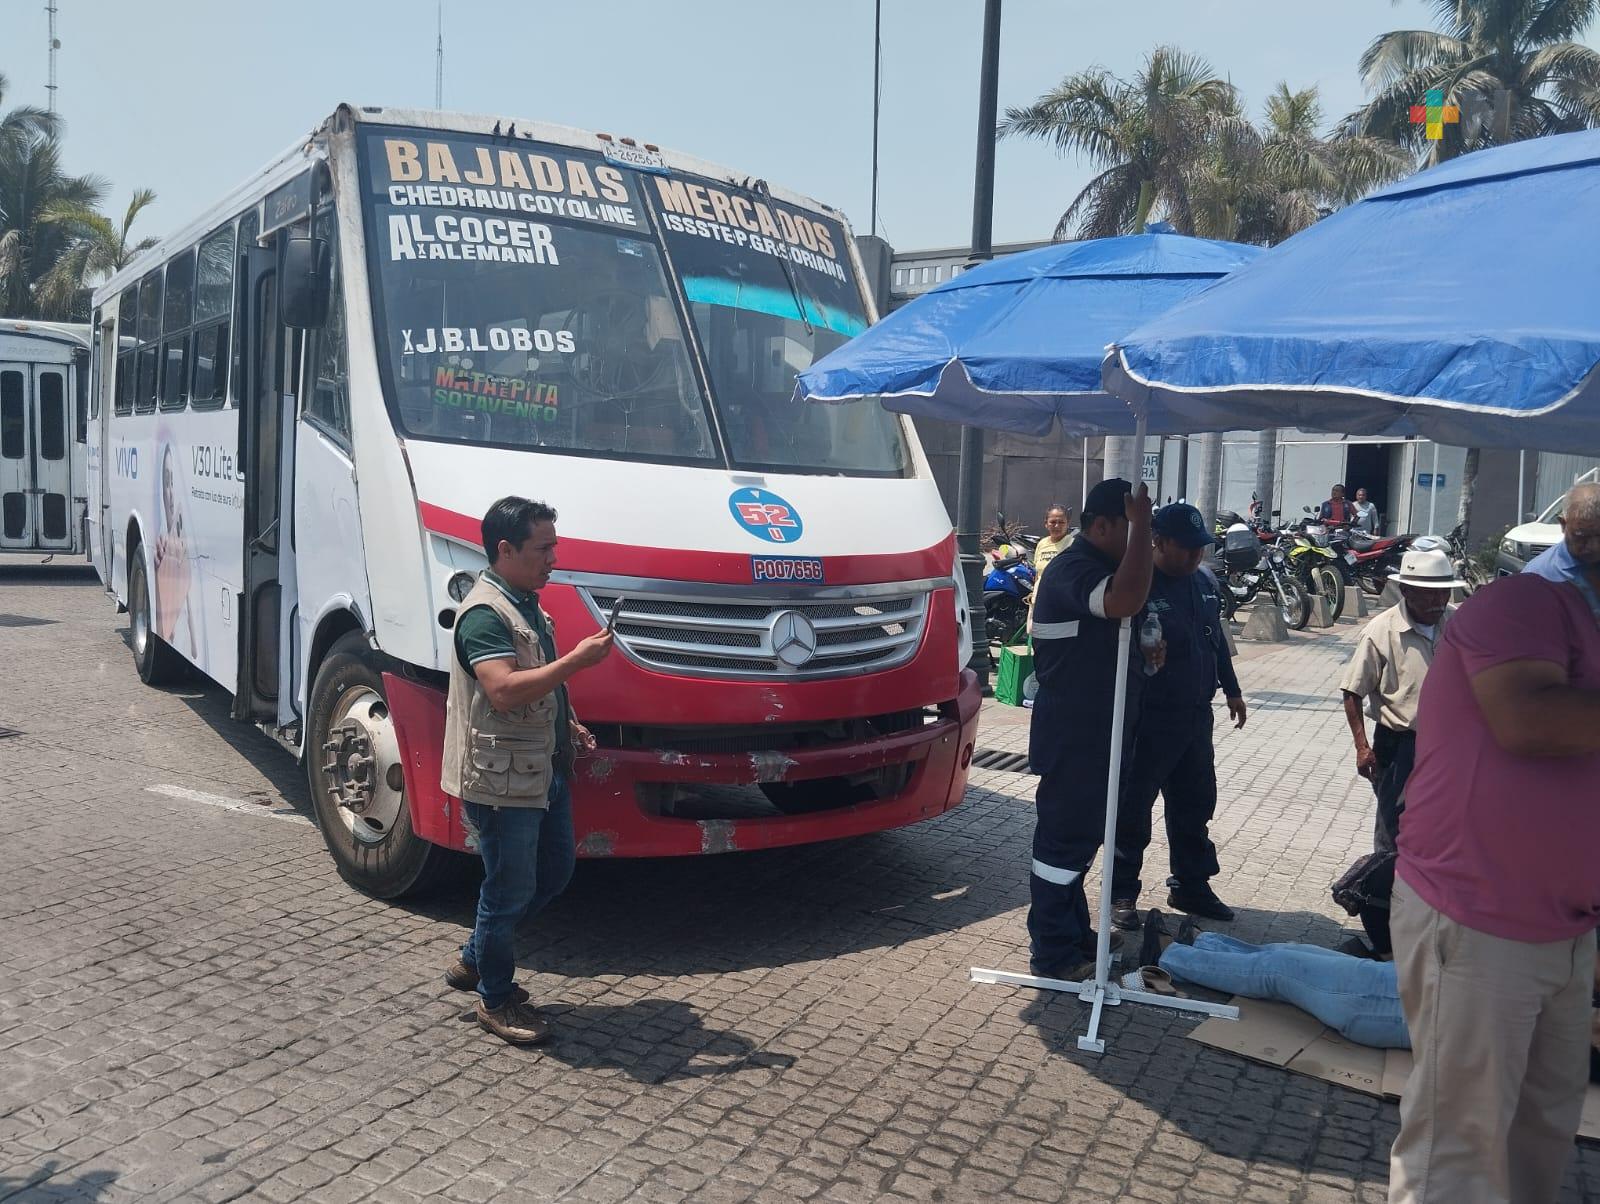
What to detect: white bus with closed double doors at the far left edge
<box><xmin>0</xmin><ymin>319</ymin><xmax>90</xmax><ymax>556</ymax></box>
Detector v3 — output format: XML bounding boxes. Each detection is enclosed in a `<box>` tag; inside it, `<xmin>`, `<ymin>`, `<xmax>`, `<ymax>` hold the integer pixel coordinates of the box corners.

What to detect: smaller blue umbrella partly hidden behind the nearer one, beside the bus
<box><xmin>795</xmin><ymin>234</ymin><xmax>1262</xmax><ymax>435</ymax></box>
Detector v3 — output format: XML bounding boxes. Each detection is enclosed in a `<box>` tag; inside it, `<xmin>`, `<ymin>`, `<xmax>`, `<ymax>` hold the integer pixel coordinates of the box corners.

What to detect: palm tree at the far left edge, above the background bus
<box><xmin>0</xmin><ymin>77</ymin><xmax>106</xmax><ymax>317</ymax></box>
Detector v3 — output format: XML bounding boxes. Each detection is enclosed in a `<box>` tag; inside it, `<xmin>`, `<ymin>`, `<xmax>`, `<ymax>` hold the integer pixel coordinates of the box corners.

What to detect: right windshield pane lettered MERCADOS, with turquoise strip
<box><xmin>646</xmin><ymin>175</ymin><xmax>910</xmax><ymax>476</ymax></box>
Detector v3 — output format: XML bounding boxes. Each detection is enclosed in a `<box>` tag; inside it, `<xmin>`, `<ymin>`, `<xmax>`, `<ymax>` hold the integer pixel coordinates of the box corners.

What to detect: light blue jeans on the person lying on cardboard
<box><xmin>1162</xmin><ymin>932</ymin><xmax>1411</xmax><ymax>1049</ymax></box>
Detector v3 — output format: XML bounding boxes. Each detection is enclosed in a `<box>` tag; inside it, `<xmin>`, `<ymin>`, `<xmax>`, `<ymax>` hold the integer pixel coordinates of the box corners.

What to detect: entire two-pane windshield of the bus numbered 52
<box><xmin>362</xmin><ymin>126</ymin><xmax>912</xmax><ymax>477</ymax></box>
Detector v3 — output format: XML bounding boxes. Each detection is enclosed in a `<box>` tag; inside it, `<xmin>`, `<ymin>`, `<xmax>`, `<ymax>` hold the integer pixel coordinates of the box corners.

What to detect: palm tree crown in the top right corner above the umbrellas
<box><xmin>1342</xmin><ymin>0</ymin><xmax>1600</xmax><ymax>163</ymax></box>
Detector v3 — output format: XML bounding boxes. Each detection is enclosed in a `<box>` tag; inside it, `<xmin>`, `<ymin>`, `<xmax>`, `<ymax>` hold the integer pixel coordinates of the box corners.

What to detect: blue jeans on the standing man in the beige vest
<box><xmin>461</xmin><ymin>772</ymin><xmax>578</xmax><ymax>1009</ymax></box>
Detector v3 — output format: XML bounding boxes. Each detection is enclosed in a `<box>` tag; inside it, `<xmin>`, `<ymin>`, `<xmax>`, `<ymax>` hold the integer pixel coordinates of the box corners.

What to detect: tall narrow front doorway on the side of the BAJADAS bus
<box><xmin>234</xmin><ymin>234</ymin><xmax>298</xmax><ymax>725</ymax></box>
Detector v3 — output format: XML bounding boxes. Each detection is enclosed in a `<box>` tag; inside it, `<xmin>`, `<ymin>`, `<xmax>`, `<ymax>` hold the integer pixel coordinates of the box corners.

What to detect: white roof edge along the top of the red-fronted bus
<box><xmin>94</xmin><ymin>104</ymin><xmax>850</xmax><ymax>306</ymax></box>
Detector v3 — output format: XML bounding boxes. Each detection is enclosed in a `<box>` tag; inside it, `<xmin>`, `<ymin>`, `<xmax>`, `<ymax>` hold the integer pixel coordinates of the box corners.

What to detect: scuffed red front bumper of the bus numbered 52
<box><xmin>384</xmin><ymin>671</ymin><xmax>982</xmax><ymax>857</ymax></box>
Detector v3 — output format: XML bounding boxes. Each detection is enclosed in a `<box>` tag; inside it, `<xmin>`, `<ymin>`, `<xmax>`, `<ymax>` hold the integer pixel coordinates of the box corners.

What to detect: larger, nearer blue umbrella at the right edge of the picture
<box><xmin>1104</xmin><ymin>130</ymin><xmax>1600</xmax><ymax>453</ymax></box>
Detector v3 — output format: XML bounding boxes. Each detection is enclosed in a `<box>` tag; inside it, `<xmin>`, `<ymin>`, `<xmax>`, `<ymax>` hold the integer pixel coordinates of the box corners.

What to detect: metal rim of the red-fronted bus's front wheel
<box><xmin>320</xmin><ymin>685</ymin><xmax>405</xmax><ymax>844</ymax></box>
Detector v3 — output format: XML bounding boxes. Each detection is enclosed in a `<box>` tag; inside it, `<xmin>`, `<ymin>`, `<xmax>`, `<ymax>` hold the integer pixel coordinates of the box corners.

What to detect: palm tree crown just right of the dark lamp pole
<box><xmin>1000</xmin><ymin>46</ymin><xmax>1256</xmax><ymax>240</ymax></box>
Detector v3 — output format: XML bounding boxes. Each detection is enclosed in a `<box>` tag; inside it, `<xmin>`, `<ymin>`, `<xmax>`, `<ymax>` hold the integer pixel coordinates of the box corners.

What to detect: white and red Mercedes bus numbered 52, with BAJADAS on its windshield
<box><xmin>90</xmin><ymin>106</ymin><xmax>979</xmax><ymax>897</ymax></box>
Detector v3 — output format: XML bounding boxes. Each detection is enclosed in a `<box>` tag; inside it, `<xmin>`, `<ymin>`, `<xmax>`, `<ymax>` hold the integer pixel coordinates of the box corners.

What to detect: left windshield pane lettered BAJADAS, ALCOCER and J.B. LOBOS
<box><xmin>363</xmin><ymin>128</ymin><xmax>718</xmax><ymax>463</ymax></box>
